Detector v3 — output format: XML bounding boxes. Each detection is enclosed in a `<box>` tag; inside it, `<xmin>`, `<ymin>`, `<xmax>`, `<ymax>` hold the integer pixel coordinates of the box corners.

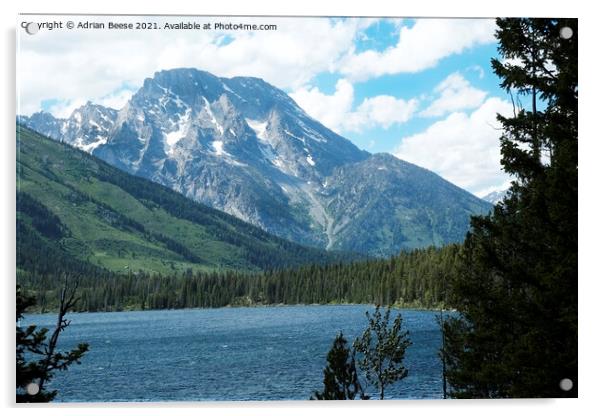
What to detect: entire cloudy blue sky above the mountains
<box><xmin>17</xmin><ymin>16</ymin><xmax>512</xmax><ymax>196</ymax></box>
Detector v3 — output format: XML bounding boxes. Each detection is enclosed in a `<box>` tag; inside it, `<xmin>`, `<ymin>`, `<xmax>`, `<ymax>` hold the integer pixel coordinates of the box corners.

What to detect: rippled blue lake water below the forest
<box><xmin>22</xmin><ymin>305</ymin><xmax>442</xmax><ymax>402</ymax></box>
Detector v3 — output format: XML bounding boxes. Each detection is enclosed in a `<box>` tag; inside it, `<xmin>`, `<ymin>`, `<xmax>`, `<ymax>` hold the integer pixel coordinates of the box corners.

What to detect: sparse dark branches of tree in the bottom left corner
<box><xmin>16</xmin><ymin>279</ymin><xmax>88</xmax><ymax>403</ymax></box>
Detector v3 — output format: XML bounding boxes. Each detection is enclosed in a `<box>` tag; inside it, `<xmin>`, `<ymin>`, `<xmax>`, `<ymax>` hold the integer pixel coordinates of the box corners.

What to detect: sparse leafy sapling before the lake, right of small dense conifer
<box><xmin>353</xmin><ymin>306</ymin><xmax>412</xmax><ymax>400</ymax></box>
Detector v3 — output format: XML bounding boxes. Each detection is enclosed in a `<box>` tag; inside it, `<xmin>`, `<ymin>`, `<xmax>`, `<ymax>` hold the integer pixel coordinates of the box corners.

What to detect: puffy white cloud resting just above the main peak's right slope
<box><xmin>290</xmin><ymin>79</ymin><xmax>418</xmax><ymax>133</ymax></box>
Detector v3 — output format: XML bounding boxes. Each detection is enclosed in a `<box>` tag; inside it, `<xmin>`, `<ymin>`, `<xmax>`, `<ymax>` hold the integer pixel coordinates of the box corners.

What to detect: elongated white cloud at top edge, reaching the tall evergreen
<box><xmin>339</xmin><ymin>19</ymin><xmax>496</xmax><ymax>81</ymax></box>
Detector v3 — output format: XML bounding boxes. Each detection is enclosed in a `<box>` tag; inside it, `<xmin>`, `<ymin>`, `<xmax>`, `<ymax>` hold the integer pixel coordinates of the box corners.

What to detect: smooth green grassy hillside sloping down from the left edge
<box><xmin>17</xmin><ymin>126</ymin><xmax>357</xmax><ymax>277</ymax></box>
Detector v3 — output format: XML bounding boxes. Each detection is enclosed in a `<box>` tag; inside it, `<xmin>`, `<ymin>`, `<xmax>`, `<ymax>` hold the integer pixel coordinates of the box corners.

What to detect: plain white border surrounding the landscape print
<box><xmin>0</xmin><ymin>0</ymin><xmax>602</xmax><ymax>416</ymax></box>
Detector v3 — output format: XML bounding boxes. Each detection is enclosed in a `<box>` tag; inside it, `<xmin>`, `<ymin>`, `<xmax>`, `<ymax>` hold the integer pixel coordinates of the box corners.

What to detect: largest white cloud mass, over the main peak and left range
<box><xmin>17</xmin><ymin>16</ymin><xmax>366</xmax><ymax>114</ymax></box>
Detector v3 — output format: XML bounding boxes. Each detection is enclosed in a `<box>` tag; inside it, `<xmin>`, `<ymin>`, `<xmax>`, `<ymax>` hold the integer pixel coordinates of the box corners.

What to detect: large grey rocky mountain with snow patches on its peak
<box><xmin>20</xmin><ymin>68</ymin><xmax>491</xmax><ymax>255</ymax></box>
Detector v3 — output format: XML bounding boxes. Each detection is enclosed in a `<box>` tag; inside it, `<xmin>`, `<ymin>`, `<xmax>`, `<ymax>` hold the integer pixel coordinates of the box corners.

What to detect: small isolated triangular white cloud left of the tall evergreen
<box><xmin>421</xmin><ymin>72</ymin><xmax>487</xmax><ymax>117</ymax></box>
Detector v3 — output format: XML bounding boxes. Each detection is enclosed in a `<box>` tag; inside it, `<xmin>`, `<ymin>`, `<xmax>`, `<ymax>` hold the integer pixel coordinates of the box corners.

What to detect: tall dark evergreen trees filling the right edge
<box><xmin>443</xmin><ymin>19</ymin><xmax>578</xmax><ymax>398</ymax></box>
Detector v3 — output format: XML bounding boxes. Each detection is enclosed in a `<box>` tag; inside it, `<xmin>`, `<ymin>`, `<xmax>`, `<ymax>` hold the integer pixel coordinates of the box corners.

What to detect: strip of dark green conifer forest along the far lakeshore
<box><xmin>20</xmin><ymin>245</ymin><xmax>460</xmax><ymax>311</ymax></box>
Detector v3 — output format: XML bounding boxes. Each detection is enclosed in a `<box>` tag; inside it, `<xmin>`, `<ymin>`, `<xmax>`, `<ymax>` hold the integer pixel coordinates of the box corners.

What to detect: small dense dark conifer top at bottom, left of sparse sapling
<box><xmin>312</xmin><ymin>332</ymin><xmax>368</xmax><ymax>400</ymax></box>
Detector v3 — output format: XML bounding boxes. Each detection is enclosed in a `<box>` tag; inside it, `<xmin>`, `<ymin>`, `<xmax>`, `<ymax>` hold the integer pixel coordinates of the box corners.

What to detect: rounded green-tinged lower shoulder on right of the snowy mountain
<box><xmin>321</xmin><ymin>153</ymin><xmax>489</xmax><ymax>256</ymax></box>
